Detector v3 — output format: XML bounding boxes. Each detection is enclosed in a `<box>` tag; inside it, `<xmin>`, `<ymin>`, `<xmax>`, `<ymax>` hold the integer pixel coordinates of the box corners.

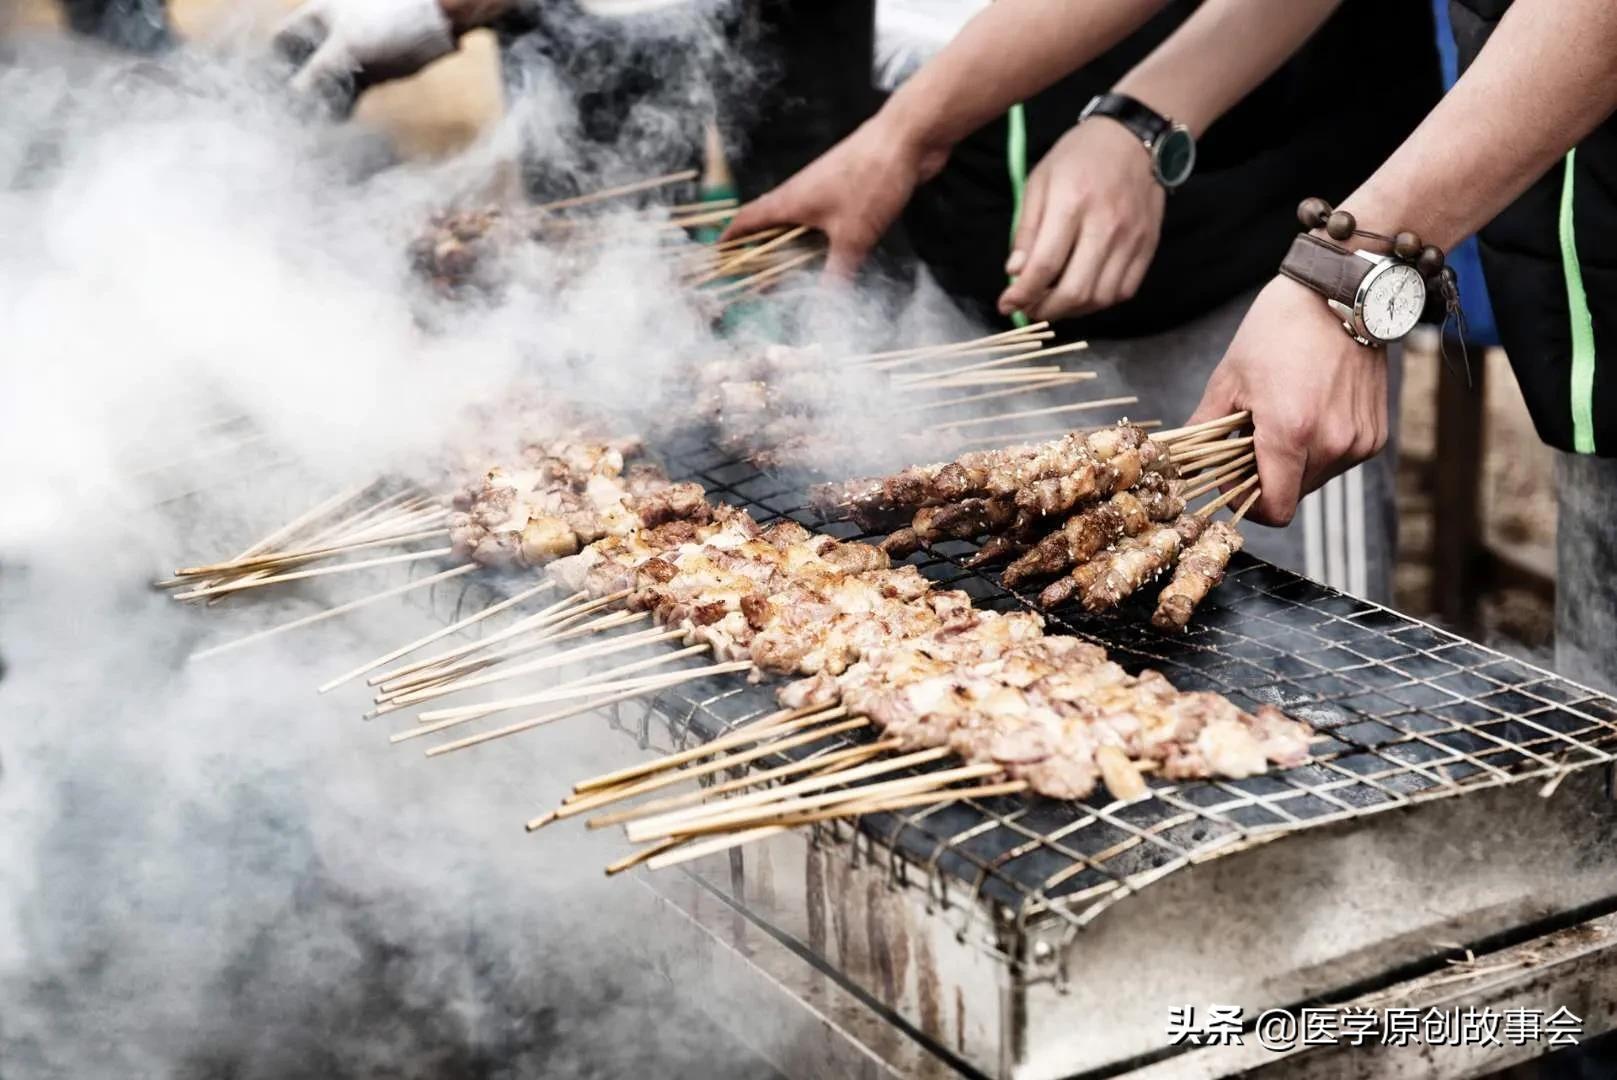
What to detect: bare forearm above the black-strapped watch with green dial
<box><xmin>1116</xmin><ymin>0</ymin><xmax>1345</xmax><ymax>137</ymax></box>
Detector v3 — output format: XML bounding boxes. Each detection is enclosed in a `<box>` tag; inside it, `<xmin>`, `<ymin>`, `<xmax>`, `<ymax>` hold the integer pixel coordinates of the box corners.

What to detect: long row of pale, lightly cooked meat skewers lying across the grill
<box><xmin>284</xmin><ymin>428</ymin><xmax>1308</xmax><ymax>855</ymax></box>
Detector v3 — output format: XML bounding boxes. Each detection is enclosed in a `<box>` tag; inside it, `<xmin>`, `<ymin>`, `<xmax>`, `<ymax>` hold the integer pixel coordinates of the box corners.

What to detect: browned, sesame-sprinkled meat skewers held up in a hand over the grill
<box><xmin>812</xmin><ymin>412</ymin><xmax>1258</xmax><ymax>631</ymax></box>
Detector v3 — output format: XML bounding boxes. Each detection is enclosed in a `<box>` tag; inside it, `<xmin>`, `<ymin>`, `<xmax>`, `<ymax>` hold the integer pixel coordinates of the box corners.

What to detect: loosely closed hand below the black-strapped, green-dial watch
<box><xmin>999</xmin><ymin>120</ymin><xmax>1167</xmax><ymax>319</ymax></box>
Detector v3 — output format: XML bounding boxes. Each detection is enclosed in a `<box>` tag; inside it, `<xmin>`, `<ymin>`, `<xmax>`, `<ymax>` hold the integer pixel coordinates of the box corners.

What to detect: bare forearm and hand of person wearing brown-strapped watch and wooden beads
<box><xmin>1192</xmin><ymin>0</ymin><xmax>1617</xmax><ymax>524</ymax></box>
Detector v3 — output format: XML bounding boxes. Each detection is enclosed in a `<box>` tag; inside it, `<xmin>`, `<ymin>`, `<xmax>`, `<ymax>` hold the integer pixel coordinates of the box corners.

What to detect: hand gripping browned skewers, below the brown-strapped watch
<box><xmin>1188</xmin><ymin>278</ymin><xmax>1387</xmax><ymax>525</ymax></box>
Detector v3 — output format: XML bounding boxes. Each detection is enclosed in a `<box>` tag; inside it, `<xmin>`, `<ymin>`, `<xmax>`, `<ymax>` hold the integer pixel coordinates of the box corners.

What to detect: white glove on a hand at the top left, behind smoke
<box><xmin>275</xmin><ymin>0</ymin><xmax>454</xmax><ymax>92</ymax></box>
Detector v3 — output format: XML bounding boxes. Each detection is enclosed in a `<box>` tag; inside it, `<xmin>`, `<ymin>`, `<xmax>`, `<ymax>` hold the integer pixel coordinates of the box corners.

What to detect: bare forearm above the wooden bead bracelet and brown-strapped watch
<box><xmin>1342</xmin><ymin>0</ymin><xmax>1617</xmax><ymax>249</ymax></box>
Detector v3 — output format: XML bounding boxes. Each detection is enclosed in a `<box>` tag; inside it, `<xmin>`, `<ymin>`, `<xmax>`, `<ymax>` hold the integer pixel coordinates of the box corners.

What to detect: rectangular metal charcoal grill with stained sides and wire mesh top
<box><xmin>426</xmin><ymin>440</ymin><xmax>1617</xmax><ymax>1078</ymax></box>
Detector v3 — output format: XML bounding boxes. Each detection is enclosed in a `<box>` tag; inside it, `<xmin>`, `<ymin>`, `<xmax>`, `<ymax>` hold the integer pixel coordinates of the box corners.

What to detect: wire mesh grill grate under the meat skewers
<box><xmin>578</xmin><ymin>440</ymin><xmax>1617</xmax><ymax>925</ymax></box>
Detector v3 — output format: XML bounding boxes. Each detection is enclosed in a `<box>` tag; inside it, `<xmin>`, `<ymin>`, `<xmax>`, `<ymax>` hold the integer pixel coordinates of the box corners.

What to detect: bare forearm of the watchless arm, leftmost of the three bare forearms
<box><xmin>881</xmin><ymin>0</ymin><xmax>1167</xmax><ymax>152</ymax></box>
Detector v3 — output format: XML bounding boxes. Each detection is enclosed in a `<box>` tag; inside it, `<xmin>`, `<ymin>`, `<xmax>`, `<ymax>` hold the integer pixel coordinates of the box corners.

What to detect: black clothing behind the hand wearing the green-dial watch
<box><xmin>906</xmin><ymin>0</ymin><xmax>1441</xmax><ymax>338</ymax></box>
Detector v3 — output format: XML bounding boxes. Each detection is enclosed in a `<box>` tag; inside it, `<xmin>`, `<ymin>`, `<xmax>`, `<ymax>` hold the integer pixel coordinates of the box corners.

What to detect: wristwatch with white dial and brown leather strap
<box><xmin>1281</xmin><ymin>233</ymin><xmax>1426</xmax><ymax>349</ymax></box>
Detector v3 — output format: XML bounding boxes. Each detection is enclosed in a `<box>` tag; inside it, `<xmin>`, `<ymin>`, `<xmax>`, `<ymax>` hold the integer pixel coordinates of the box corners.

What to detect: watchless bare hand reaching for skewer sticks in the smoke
<box><xmin>721</xmin><ymin>115</ymin><xmax>949</xmax><ymax>278</ymax></box>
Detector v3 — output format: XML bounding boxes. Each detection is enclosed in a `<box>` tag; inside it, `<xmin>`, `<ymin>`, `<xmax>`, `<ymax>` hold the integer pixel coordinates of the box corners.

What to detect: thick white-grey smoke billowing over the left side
<box><xmin>0</xmin><ymin>16</ymin><xmax>834</xmax><ymax>1078</ymax></box>
